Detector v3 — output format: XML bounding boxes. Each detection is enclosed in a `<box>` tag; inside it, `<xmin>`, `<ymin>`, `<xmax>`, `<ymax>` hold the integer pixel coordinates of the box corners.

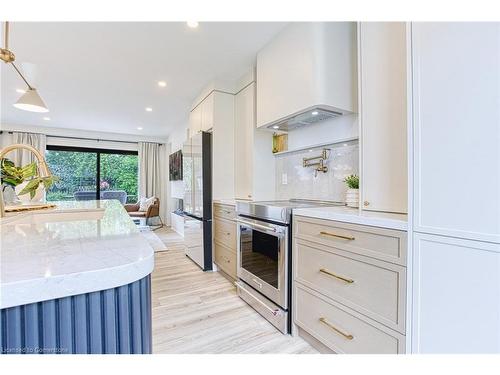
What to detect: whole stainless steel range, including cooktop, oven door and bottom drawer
<box><xmin>236</xmin><ymin>200</ymin><xmax>335</xmax><ymax>334</ymax></box>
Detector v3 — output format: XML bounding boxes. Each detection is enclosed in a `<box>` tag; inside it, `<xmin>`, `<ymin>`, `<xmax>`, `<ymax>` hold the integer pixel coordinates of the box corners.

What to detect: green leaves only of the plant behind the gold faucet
<box><xmin>1</xmin><ymin>158</ymin><xmax>58</xmax><ymax>198</ymax></box>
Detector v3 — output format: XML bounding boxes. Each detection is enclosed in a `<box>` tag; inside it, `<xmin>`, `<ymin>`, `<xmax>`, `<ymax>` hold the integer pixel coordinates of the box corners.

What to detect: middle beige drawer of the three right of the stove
<box><xmin>294</xmin><ymin>240</ymin><xmax>406</xmax><ymax>333</ymax></box>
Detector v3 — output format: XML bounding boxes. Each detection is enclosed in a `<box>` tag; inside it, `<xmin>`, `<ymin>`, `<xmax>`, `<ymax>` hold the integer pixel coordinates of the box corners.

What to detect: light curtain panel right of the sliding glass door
<box><xmin>139</xmin><ymin>142</ymin><xmax>161</xmax><ymax>200</ymax></box>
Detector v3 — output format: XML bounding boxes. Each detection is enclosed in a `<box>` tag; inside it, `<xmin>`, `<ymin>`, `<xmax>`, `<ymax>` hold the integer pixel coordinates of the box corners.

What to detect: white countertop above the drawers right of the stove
<box><xmin>293</xmin><ymin>206</ymin><xmax>408</xmax><ymax>231</ymax></box>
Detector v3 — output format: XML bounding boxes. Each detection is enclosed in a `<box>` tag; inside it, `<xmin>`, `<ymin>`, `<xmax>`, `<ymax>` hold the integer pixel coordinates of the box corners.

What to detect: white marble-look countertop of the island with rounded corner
<box><xmin>0</xmin><ymin>200</ymin><xmax>154</xmax><ymax>309</ymax></box>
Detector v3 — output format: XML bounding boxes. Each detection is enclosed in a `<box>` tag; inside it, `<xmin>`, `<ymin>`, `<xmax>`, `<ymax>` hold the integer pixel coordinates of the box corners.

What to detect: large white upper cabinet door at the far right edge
<box><xmin>412</xmin><ymin>22</ymin><xmax>500</xmax><ymax>243</ymax></box>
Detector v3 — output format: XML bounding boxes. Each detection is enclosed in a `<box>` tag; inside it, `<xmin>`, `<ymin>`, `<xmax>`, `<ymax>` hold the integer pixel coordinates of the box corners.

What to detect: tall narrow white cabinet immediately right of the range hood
<box><xmin>358</xmin><ymin>22</ymin><xmax>408</xmax><ymax>213</ymax></box>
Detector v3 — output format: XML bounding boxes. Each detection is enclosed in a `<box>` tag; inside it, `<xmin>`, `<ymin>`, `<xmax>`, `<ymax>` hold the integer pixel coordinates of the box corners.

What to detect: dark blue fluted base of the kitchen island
<box><xmin>0</xmin><ymin>275</ymin><xmax>152</xmax><ymax>354</ymax></box>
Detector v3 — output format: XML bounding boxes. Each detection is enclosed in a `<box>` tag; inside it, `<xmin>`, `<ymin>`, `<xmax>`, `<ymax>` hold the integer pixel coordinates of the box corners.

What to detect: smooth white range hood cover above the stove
<box><xmin>257</xmin><ymin>22</ymin><xmax>357</xmax><ymax>127</ymax></box>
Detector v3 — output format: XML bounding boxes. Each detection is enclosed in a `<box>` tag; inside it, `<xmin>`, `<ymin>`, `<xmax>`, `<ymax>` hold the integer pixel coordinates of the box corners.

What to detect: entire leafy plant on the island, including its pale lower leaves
<box><xmin>1</xmin><ymin>158</ymin><xmax>58</xmax><ymax>203</ymax></box>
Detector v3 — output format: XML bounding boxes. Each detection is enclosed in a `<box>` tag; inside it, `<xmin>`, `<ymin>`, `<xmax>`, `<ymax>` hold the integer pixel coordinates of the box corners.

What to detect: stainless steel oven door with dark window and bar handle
<box><xmin>237</xmin><ymin>216</ymin><xmax>289</xmax><ymax>310</ymax></box>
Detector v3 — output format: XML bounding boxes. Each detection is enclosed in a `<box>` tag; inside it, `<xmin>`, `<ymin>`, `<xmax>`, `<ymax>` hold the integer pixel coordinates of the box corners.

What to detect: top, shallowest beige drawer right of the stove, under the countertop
<box><xmin>294</xmin><ymin>216</ymin><xmax>406</xmax><ymax>266</ymax></box>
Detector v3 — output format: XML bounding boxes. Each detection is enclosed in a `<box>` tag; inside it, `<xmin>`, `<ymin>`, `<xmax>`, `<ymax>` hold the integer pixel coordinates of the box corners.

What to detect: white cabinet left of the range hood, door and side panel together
<box><xmin>234</xmin><ymin>82</ymin><xmax>275</xmax><ymax>200</ymax></box>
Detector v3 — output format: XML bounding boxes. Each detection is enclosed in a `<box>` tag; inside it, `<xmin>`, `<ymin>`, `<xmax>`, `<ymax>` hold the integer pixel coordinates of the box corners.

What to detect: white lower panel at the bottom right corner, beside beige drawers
<box><xmin>412</xmin><ymin>233</ymin><xmax>500</xmax><ymax>353</ymax></box>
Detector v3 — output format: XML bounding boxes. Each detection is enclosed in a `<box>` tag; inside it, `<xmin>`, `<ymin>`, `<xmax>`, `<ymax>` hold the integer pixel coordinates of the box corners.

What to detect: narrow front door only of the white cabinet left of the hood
<box><xmin>234</xmin><ymin>83</ymin><xmax>255</xmax><ymax>199</ymax></box>
